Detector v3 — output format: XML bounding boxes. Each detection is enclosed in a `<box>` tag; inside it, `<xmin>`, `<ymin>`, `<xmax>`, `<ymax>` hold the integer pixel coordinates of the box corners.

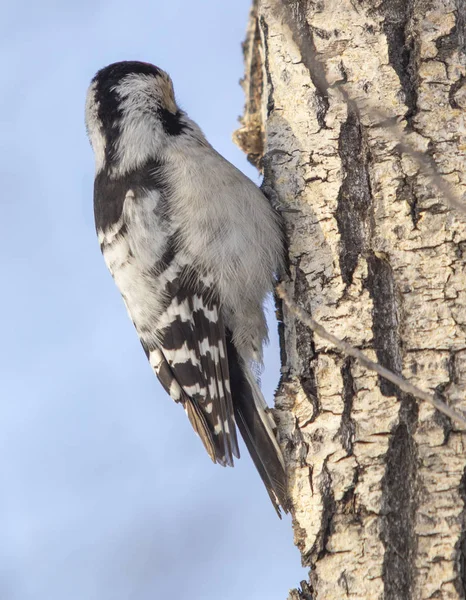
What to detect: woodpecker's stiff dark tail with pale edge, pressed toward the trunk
<box><xmin>227</xmin><ymin>333</ymin><xmax>288</xmax><ymax>518</ymax></box>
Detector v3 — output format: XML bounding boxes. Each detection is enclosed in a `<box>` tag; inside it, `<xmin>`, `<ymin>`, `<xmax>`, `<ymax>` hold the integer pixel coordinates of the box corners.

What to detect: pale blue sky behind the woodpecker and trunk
<box><xmin>0</xmin><ymin>0</ymin><xmax>305</xmax><ymax>600</ymax></box>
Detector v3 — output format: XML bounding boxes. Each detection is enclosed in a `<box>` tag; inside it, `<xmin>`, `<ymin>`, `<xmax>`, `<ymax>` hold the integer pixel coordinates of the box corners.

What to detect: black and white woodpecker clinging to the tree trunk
<box><xmin>85</xmin><ymin>61</ymin><xmax>288</xmax><ymax>516</ymax></box>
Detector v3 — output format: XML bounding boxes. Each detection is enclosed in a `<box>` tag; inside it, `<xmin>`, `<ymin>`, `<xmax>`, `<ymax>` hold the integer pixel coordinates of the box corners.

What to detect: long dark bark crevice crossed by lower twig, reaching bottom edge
<box><xmin>365</xmin><ymin>253</ymin><xmax>418</xmax><ymax>600</ymax></box>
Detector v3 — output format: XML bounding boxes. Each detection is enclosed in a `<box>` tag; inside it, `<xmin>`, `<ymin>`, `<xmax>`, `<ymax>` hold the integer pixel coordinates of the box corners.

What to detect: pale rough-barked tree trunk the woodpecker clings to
<box><xmin>236</xmin><ymin>0</ymin><xmax>466</xmax><ymax>600</ymax></box>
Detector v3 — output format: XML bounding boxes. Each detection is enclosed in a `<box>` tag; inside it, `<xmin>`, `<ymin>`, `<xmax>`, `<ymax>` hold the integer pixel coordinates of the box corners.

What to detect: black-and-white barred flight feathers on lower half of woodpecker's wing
<box><xmin>146</xmin><ymin>258</ymin><xmax>239</xmax><ymax>465</ymax></box>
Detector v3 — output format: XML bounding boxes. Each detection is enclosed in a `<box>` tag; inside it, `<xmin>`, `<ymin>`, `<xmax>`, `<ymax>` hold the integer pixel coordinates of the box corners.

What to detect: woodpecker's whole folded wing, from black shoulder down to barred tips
<box><xmin>95</xmin><ymin>169</ymin><xmax>239</xmax><ymax>465</ymax></box>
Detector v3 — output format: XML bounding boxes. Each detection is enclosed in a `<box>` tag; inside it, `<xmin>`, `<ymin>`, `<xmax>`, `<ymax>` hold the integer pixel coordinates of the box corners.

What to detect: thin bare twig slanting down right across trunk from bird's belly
<box><xmin>277</xmin><ymin>284</ymin><xmax>466</xmax><ymax>426</ymax></box>
